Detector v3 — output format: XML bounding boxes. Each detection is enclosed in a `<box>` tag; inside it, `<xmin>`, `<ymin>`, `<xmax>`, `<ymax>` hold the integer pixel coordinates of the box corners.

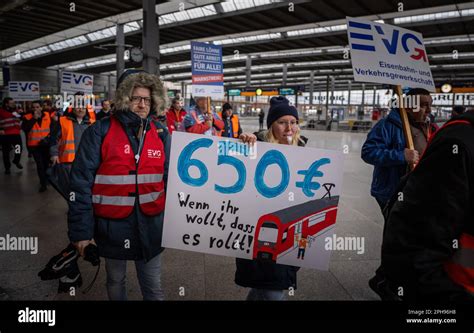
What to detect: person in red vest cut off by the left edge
<box><xmin>0</xmin><ymin>97</ymin><xmax>23</xmax><ymax>175</ymax></box>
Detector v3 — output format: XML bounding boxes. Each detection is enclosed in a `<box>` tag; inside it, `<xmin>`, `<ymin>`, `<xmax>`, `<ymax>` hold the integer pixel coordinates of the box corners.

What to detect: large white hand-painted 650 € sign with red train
<box><xmin>163</xmin><ymin>132</ymin><xmax>343</xmax><ymax>270</ymax></box>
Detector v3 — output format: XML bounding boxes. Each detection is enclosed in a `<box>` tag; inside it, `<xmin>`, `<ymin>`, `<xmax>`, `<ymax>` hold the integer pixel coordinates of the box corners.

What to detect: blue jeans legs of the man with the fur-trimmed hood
<box><xmin>105</xmin><ymin>255</ymin><xmax>165</xmax><ymax>301</ymax></box>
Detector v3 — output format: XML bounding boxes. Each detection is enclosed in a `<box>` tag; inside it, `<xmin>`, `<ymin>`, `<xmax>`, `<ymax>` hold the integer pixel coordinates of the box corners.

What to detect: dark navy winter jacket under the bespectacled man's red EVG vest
<box><xmin>68</xmin><ymin>111</ymin><xmax>171</xmax><ymax>261</ymax></box>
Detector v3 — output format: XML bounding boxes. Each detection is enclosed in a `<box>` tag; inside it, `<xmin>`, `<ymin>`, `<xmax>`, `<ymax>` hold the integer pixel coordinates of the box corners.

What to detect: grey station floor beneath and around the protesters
<box><xmin>0</xmin><ymin>118</ymin><xmax>383</xmax><ymax>300</ymax></box>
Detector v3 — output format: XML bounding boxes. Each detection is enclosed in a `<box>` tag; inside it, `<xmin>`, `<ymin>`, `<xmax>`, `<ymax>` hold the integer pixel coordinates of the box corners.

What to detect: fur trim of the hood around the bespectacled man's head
<box><xmin>114</xmin><ymin>72</ymin><xmax>167</xmax><ymax>115</ymax></box>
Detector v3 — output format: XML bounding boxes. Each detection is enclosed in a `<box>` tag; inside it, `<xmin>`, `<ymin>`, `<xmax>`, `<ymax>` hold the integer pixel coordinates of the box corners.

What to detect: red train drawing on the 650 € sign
<box><xmin>253</xmin><ymin>196</ymin><xmax>339</xmax><ymax>262</ymax></box>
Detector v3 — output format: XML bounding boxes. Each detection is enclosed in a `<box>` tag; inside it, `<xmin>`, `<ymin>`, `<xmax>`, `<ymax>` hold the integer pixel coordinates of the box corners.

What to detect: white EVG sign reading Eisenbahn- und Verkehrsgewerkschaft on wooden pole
<box><xmin>346</xmin><ymin>17</ymin><xmax>436</xmax><ymax>92</ymax></box>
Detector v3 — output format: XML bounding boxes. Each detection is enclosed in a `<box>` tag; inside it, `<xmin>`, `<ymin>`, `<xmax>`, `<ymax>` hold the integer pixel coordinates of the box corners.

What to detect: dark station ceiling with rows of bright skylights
<box><xmin>0</xmin><ymin>0</ymin><xmax>474</xmax><ymax>89</ymax></box>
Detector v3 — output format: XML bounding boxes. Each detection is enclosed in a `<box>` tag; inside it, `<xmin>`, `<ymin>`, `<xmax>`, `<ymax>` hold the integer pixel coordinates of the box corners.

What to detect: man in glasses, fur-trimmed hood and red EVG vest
<box><xmin>68</xmin><ymin>71</ymin><xmax>170</xmax><ymax>300</ymax></box>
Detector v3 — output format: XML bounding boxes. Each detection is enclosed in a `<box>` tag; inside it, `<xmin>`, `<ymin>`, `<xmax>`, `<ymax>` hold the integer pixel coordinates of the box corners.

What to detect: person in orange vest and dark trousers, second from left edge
<box><xmin>21</xmin><ymin>101</ymin><xmax>51</xmax><ymax>192</ymax></box>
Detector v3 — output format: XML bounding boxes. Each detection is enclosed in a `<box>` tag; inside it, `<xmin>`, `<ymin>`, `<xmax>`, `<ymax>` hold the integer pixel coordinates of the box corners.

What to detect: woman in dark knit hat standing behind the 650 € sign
<box><xmin>235</xmin><ymin>96</ymin><xmax>308</xmax><ymax>301</ymax></box>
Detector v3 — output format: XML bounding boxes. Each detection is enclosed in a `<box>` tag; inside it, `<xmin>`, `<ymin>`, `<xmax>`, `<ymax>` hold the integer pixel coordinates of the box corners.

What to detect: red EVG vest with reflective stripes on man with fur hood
<box><xmin>92</xmin><ymin>116</ymin><xmax>165</xmax><ymax>219</ymax></box>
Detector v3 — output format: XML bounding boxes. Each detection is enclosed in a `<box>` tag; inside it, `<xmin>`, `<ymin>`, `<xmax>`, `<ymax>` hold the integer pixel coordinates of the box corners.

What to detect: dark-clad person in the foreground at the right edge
<box><xmin>382</xmin><ymin>113</ymin><xmax>474</xmax><ymax>302</ymax></box>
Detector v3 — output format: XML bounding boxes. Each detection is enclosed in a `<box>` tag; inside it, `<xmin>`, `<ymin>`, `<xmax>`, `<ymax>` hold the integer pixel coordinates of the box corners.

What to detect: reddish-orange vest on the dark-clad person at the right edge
<box><xmin>444</xmin><ymin>233</ymin><xmax>474</xmax><ymax>293</ymax></box>
